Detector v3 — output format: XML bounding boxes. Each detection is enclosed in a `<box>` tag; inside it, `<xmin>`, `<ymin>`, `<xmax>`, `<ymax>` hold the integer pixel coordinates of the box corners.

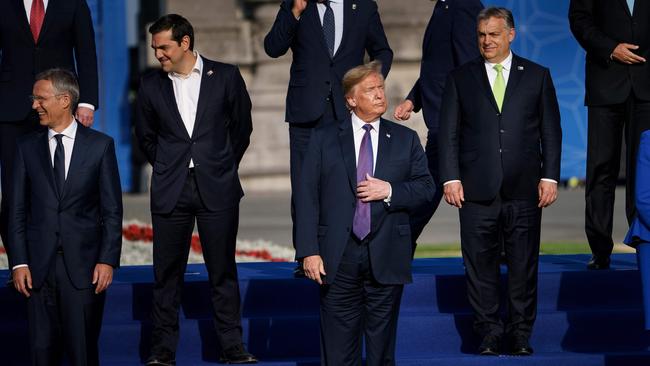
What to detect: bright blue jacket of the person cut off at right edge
<box><xmin>623</xmin><ymin>130</ymin><xmax>650</xmax><ymax>246</ymax></box>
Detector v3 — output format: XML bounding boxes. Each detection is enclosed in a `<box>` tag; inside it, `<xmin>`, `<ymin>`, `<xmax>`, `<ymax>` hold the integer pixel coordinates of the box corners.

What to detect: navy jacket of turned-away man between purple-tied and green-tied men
<box><xmin>406</xmin><ymin>0</ymin><xmax>483</xmax><ymax>131</ymax></box>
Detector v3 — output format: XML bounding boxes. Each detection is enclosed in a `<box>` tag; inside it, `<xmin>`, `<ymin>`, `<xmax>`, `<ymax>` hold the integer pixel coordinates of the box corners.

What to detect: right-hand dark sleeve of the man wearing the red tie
<box><xmin>74</xmin><ymin>0</ymin><xmax>99</xmax><ymax>110</ymax></box>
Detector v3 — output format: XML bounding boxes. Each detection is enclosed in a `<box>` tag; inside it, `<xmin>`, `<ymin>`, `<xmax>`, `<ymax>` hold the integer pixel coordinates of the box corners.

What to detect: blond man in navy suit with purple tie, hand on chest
<box><xmin>296</xmin><ymin>62</ymin><xmax>434</xmax><ymax>366</ymax></box>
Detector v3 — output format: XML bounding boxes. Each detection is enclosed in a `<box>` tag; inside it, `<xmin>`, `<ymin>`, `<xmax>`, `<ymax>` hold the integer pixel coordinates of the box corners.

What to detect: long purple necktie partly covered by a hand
<box><xmin>352</xmin><ymin>124</ymin><xmax>372</xmax><ymax>240</ymax></box>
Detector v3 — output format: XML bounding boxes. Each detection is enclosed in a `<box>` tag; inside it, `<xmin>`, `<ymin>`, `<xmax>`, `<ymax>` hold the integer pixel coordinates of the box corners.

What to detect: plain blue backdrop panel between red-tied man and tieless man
<box><xmin>87</xmin><ymin>0</ymin><xmax>131</xmax><ymax>191</ymax></box>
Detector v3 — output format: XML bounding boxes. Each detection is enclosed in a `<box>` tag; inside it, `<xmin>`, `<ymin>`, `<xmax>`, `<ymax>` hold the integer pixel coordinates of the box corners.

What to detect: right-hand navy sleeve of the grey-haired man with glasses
<box><xmin>97</xmin><ymin>139</ymin><xmax>123</xmax><ymax>268</ymax></box>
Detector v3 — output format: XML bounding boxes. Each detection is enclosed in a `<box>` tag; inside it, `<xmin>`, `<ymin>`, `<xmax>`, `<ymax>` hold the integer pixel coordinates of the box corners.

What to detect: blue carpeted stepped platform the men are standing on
<box><xmin>0</xmin><ymin>255</ymin><xmax>650</xmax><ymax>366</ymax></box>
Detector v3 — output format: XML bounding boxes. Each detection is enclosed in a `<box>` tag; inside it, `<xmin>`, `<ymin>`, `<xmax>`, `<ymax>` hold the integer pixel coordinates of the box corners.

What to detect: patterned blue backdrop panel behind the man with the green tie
<box><xmin>483</xmin><ymin>0</ymin><xmax>587</xmax><ymax>179</ymax></box>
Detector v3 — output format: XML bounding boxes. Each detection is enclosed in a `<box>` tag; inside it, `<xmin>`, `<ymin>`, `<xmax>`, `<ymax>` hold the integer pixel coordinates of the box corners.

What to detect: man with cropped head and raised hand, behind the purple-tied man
<box><xmin>264</xmin><ymin>0</ymin><xmax>393</xmax><ymax>266</ymax></box>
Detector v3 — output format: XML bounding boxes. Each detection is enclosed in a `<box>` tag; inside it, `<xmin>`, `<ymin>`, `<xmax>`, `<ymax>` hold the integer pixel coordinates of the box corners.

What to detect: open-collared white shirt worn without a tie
<box><xmin>167</xmin><ymin>51</ymin><xmax>203</xmax><ymax>168</ymax></box>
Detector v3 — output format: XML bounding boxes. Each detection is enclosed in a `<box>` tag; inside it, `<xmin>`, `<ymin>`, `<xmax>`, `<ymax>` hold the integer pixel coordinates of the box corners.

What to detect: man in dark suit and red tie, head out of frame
<box><xmin>0</xmin><ymin>0</ymin><xmax>98</xmax><ymax>252</ymax></box>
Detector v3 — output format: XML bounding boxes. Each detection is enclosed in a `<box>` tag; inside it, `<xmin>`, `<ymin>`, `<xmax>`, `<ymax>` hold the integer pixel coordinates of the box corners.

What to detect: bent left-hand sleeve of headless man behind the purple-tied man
<box><xmin>264</xmin><ymin>0</ymin><xmax>299</xmax><ymax>58</ymax></box>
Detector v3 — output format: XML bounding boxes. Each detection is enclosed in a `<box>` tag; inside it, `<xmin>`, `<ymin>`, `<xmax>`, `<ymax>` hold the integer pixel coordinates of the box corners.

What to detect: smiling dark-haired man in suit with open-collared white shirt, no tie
<box><xmin>136</xmin><ymin>14</ymin><xmax>256</xmax><ymax>365</ymax></box>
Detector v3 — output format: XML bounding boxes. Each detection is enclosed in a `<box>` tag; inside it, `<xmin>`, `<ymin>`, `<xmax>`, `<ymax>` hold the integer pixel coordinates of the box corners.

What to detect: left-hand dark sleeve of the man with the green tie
<box><xmin>438</xmin><ymin>74</ymin><xmax>461</xmax><ymax>184</ymax></box>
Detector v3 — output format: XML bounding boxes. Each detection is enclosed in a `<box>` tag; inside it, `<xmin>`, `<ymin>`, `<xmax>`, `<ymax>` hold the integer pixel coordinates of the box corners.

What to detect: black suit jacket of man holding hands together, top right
<box><xmin>569</xmin><ymin>0</ymin><xmax>650</xmax><ymax>106</ymax></box>
